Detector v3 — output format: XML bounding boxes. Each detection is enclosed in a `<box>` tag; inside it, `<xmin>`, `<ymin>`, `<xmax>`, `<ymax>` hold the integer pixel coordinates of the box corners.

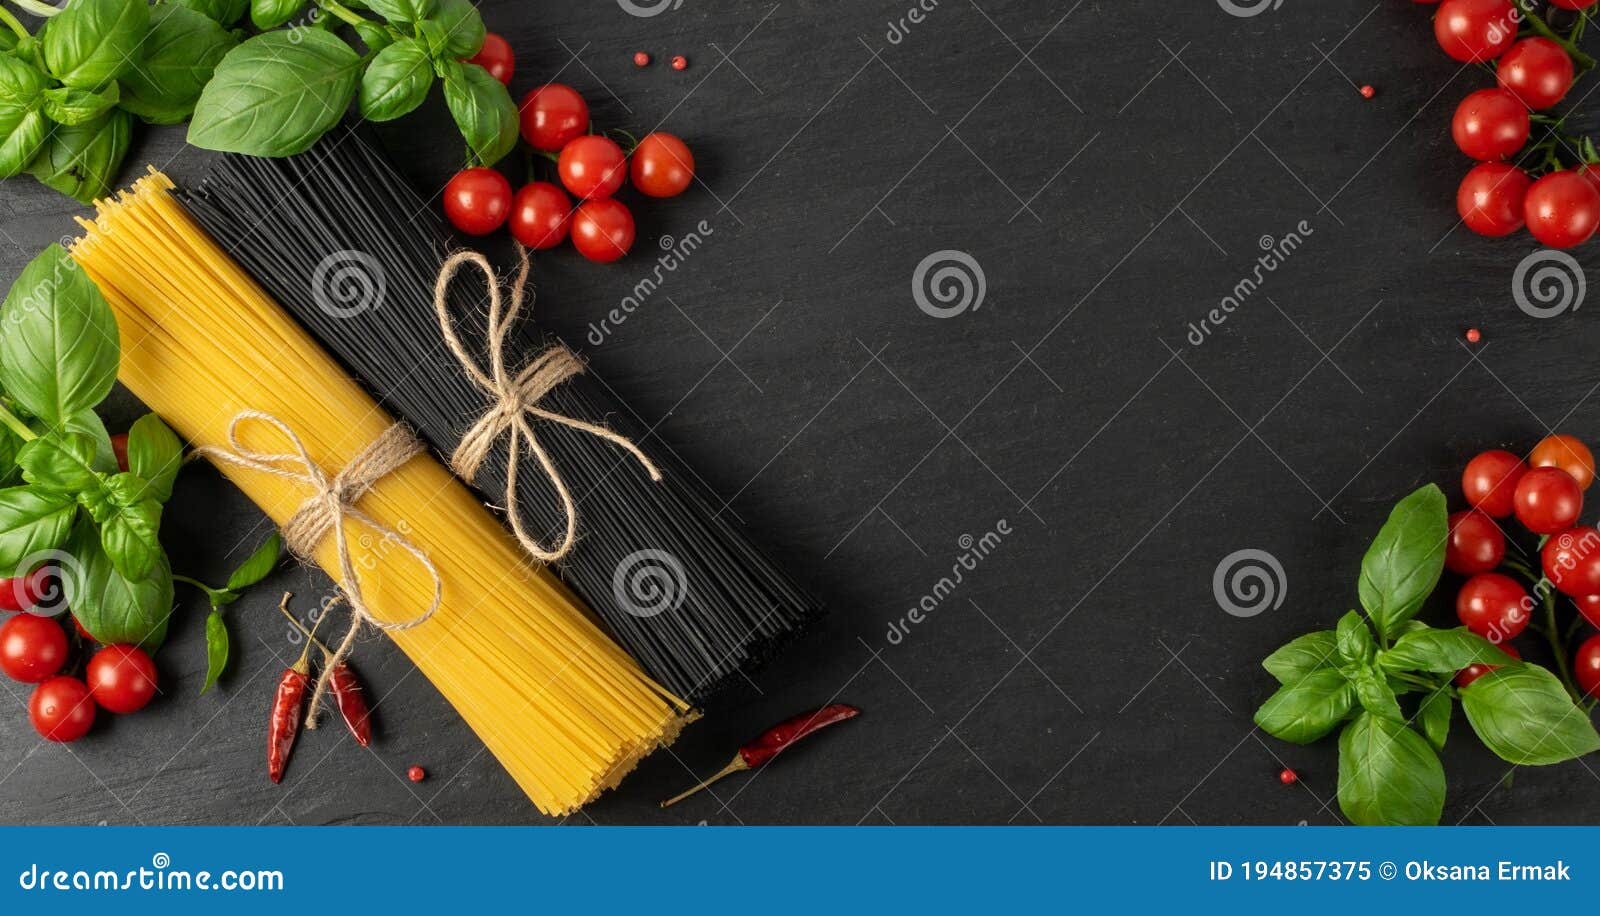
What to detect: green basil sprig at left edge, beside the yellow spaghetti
<box><xmin>0</xmin><ymin>245</ymin><xmax>182</xmax><ymax>652</ymax></box>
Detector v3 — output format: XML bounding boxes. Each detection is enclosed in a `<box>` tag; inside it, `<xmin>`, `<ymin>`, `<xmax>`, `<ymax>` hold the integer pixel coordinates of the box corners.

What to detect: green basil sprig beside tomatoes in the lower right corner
<box><xmin>1256</xmin><ymin>484</ymin><xmax>1600</xmax><ymax>825</ymax></box>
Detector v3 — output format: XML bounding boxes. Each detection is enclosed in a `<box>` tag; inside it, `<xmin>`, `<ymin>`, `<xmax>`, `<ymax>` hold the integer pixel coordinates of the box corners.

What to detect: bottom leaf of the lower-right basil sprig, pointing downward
<box><xmin>1339</xmin><ymin>713</ymin><xmax>1445</xmax><ymax>826</ymax></box>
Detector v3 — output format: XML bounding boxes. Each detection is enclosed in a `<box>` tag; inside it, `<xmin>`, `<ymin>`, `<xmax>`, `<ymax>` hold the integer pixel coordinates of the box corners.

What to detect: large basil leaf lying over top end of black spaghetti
<box><xmin>189</xmin><ymin>30</ymin><xmax>362</xmax><ymax>157</ymax></box>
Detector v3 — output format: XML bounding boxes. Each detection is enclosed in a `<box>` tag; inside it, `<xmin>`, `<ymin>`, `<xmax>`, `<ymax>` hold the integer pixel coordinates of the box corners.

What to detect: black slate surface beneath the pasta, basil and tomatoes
<box><xmin>0</xmin><ymin>0</ymin><xmax>1600</xmax><ymax>823</ymax></box>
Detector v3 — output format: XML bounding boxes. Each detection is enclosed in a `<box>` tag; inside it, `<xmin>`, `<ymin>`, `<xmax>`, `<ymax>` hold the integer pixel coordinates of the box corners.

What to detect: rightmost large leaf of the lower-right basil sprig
<box><xmin>1461</xmin><ymin>665</ymin><xmax>1600</xmax><ymax>765</ymax></box>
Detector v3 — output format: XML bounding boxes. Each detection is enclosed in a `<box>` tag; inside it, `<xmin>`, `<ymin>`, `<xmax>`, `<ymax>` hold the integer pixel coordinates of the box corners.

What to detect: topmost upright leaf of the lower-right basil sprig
<box><xmin>1358</xmin><ymin>484</ymin><xmax>1450</xmax><ymax>636</ymax></box>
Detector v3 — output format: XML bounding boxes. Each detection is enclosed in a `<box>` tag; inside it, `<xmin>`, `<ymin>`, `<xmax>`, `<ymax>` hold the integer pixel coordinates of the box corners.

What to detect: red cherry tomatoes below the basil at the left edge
<box><xmin>0</xmin><ymin>568</ymin><xmax>157</xmax><ymax>743</ymax></box>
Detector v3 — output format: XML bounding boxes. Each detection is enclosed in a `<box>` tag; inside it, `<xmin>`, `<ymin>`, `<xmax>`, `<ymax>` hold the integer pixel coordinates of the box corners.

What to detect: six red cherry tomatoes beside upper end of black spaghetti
<box><xmin>445</xmin><ymin>83</ymin><xmax>694</xmax><ymax>264</ymax></box>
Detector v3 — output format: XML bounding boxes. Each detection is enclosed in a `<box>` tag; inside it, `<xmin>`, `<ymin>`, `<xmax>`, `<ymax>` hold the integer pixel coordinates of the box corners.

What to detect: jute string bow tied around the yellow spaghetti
<box><xmin>194</xmin><ymin>410</ymin><xmax>443</xmax><ymax>729</ymax></box>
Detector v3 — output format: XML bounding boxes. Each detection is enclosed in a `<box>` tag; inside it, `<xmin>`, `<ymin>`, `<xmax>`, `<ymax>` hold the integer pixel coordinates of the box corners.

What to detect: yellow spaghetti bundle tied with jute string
<box><xmin>70</xmin><ymin>170</ymin><xmax>686</xmax><ymax>815</ymax></box>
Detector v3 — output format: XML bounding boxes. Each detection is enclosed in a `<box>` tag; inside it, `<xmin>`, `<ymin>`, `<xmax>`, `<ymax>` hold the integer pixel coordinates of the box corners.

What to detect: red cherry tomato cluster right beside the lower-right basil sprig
<box><xmin>1445</xmin><ymin>434</ymin><xmax>1600</xmax><ymax>697</ymax></box>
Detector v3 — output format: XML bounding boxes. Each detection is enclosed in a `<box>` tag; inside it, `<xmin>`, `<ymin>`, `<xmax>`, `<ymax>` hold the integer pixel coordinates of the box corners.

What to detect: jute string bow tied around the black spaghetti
<box><xmin>434</xmin><ymin>245</ymin><xmax>661</xmax><ymax>564</ymax></box>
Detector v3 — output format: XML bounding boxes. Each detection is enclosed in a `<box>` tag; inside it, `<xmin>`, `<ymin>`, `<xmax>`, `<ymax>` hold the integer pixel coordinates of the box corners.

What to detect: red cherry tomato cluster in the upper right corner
<box><xmin>1418</xmin><ymin>0</ymin><xmax>1600</xmax><ymax>248</ymax></box>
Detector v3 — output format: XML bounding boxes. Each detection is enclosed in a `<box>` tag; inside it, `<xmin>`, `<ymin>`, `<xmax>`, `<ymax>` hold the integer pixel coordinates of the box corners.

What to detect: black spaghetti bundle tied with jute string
<box><xmin>182</xmin><ymin>130</ymin><xmax>821</xmax><ymax>705</ymax></box>
